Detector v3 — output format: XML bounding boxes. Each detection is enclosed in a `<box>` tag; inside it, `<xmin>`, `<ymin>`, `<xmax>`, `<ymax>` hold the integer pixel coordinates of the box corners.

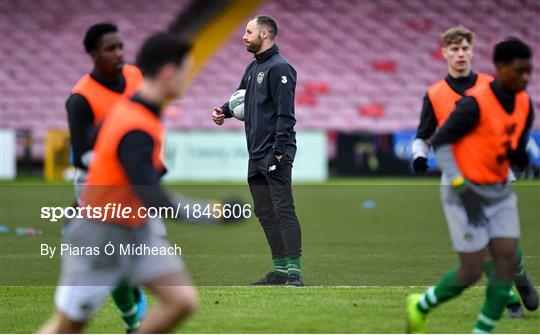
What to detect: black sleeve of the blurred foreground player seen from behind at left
<box><xmin>118</xmin><ymin>130</ymin><xmax>173</xmax><ymax>207</ymax></box>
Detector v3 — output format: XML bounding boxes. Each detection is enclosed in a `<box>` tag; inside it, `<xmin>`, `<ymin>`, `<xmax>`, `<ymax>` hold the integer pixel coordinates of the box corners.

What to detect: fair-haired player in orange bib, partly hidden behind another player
<box><xmin>413</xmin><ymin>26</ymin><xmax>538</xmax><ymax>317</ymax></box>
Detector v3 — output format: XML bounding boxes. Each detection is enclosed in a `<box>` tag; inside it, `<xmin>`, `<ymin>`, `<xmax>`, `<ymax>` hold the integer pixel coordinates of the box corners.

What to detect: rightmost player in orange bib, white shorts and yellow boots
<box><xmin>407</xmin><ymin>39</ymin><xmax>534</xmax><ymax>333</ymax></box>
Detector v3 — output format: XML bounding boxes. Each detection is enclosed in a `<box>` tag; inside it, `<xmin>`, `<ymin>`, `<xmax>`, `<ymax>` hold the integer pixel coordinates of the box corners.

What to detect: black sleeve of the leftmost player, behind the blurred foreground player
<box><xmin>66</xmin><ymin>94</ymin><xmax>94</xmax><ymax>170</ymax></box>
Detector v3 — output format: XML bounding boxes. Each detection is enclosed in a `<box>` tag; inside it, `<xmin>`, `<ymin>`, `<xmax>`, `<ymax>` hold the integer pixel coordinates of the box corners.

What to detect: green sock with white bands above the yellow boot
<box><xmin>417</xmin><ymin>270</ymin><xmax>466</xmax><ymax>313</ymax></box>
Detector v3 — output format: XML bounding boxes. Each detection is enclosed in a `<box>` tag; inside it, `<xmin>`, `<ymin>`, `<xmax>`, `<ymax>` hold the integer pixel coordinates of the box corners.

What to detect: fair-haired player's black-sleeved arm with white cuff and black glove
<box><xmin>412</xmin><ymin>93</ymin><xmax>437</xmax><ymax>175</ymax></box>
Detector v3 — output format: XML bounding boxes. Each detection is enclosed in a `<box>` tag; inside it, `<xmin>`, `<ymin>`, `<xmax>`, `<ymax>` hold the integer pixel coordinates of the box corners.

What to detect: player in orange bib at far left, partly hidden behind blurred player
<box><xmin>66</xmin><ymin>23</ymin><xmax>147</xmax><ymax>332</ymax></box>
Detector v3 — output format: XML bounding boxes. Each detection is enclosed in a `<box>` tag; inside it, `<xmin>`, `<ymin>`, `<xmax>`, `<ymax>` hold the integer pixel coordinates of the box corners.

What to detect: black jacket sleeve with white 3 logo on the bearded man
<box><xmin>269</xmin><ymin>64</ymin><xmax>296</xmax><ymax>153</ymax></box>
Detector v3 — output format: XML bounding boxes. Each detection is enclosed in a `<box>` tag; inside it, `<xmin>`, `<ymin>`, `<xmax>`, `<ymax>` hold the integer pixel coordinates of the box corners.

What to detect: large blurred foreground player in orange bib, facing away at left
<box><xmin>41</xmin><ymin>33</ymin><xmax>198</xmax><ymax>333</ymax></box>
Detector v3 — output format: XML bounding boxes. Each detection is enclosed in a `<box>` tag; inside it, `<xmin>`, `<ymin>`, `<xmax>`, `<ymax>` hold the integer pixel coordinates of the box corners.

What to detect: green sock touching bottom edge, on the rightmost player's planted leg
<box><xmin>473</xmin><ymin>274</ymin><xmax>512</xmax><ymax>333</ymax></box>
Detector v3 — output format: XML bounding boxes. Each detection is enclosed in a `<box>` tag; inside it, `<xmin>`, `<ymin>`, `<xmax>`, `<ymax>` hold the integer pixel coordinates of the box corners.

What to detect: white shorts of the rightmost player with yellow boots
<box><xmin>441</xmin><ymin>186</ymin><xmax>520</xmax><ymax>253</ymax></box>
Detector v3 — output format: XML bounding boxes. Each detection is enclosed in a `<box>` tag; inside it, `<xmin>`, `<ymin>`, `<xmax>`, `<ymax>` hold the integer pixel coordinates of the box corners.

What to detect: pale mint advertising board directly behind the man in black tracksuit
<box><xmin>164</xmin><ymin>131</ymin><xmax>328</xmax><ymax>181</ymax></box>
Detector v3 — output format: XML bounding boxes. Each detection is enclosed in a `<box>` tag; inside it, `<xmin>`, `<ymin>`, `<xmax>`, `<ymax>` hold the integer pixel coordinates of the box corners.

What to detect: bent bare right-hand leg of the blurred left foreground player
<box><xmin>139</xmin><ymin>270</ymin><xmax>199</xmax><ymax>333</ymax></box>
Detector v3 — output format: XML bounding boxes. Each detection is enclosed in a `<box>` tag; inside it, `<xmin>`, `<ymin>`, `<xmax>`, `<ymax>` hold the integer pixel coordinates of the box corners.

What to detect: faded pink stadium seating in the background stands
<box><xmin>0</xmin><ymin>0</ymin><xmax>540</xmax><ymax>158</ymax></box>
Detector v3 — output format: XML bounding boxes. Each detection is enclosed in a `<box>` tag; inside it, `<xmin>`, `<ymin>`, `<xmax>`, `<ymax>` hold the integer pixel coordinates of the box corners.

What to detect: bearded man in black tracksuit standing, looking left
<box><xmin>212</xmin><ymin>16</ymin><xmax>303</xmax><ymax>286</ymax></box>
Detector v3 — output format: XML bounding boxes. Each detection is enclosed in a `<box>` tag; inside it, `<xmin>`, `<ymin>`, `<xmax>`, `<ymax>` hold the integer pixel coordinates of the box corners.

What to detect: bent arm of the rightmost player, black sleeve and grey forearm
<box><xmin>432</xmin><ymin>97</ymin><xmax>480</xmax><ymax>183</ymax></box>
